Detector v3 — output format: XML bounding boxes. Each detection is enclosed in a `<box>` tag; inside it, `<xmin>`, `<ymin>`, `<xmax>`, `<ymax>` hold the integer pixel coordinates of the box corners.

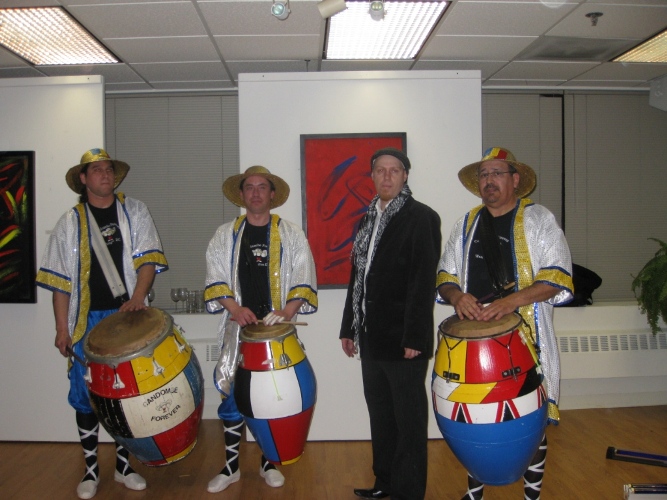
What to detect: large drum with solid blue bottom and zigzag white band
<box><xmin>432</xmin><ymin>313</ymin><xmax>548</xmax><ymax>485</ymax></box>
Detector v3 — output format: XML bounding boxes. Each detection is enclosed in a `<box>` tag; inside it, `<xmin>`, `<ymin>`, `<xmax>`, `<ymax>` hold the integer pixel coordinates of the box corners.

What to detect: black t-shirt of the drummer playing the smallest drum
<box><xmin>239</xmin><ymin>221</ymin><xmax>271</xmax><ymax>318</ymax></box>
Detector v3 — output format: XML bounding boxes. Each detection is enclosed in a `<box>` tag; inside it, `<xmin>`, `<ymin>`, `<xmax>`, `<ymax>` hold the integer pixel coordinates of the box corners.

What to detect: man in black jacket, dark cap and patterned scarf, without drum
<box><xmin>340</xmin><ymin>148</ymin><xmax>441</xmax><ymax>499</ymax></box>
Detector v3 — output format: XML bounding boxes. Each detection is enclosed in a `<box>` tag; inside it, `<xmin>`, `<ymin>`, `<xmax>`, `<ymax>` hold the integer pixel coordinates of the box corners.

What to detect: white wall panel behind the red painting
<box><xmin>239</xmin><ymin>71</ymin><xmax>482</xmax><ymax>440</ymax></box>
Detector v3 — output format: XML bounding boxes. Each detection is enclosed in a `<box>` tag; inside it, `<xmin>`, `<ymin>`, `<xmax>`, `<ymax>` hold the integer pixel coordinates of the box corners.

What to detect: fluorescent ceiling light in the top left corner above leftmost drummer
<box><xmin>0</xmin><ymin>7</ymin><xmax>118</xmax><ymax>66</ymax></box>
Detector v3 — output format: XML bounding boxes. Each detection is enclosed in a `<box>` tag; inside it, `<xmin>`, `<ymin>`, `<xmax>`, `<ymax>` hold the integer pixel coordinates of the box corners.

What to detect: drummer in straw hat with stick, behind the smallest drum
<box><xmin>204</xmin><ymin>166</ymin><xmax>317</xmax><ymax>493</ymax></box>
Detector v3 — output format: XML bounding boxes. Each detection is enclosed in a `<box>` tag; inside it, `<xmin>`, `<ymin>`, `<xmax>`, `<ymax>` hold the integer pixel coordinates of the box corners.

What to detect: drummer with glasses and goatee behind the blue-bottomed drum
<box><xmin>437</xmin><ymin>147</ymin><xmax>573</xmax><ymax>500</ymax></box>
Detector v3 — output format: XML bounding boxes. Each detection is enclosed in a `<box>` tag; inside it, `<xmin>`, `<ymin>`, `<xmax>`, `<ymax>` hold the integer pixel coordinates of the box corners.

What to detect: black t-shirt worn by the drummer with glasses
<box><xmin>468</xmin><ymin>210</ymin><xmax>514</xmax><ymax>303</ymax></box>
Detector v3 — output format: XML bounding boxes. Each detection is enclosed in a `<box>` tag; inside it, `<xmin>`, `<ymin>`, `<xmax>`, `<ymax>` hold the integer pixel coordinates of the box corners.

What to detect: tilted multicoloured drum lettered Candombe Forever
<box><xmin>84</xmin><ymin>307</ymin><xmax>204</xmax><ymax>466</ymax></box>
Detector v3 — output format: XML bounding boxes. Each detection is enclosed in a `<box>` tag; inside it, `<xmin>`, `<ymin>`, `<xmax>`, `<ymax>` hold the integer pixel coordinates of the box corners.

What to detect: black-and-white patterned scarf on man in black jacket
<box><xmin>352</xmin><ymin>183</ymin><xmax>412</xmax><ymax>348</ymax></box>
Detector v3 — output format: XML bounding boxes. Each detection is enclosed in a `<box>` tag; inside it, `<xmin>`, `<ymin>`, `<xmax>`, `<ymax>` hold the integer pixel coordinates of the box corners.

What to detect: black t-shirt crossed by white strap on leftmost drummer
<box><xmin>88</xmin><ymin>203</ymin><xmax>127</xmax><ymax>311</ymax></box>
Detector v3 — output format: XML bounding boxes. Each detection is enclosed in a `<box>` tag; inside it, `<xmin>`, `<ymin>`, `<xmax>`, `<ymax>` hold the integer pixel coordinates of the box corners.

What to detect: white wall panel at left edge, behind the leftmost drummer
<box><xmin>0</xmin><ymin>76</ymin><xmax>104</xmax><ymax>441</ymax></box>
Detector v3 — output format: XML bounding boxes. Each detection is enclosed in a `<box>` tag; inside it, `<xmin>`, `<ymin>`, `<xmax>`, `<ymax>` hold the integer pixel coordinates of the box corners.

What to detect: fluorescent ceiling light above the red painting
<box><xmin>325</xmin><ymin>0</ymin><xmax>447</xmax><ymax>59</ymax></box>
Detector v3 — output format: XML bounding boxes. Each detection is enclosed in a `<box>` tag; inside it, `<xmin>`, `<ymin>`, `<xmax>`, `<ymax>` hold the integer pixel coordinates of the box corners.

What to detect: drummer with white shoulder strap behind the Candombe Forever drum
<box><xmin>37</xmin><ymin>148</ymin><xmax>167</xmax><ymax>498</ymax></box>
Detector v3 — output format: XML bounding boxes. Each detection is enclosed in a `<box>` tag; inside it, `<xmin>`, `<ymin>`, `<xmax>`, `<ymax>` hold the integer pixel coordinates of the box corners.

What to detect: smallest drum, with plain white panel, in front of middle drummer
<box><xmin>234</xmin><ymin>324</ymin><xmax>317</xmax><ymax>465</ymax></box>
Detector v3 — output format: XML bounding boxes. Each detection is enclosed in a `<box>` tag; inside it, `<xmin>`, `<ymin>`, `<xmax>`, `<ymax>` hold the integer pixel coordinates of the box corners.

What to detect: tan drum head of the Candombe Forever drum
<box><xmin>83</xmin><ymin>307</ymin><xmax>172</xmax><ymax>363</ymax></box>
